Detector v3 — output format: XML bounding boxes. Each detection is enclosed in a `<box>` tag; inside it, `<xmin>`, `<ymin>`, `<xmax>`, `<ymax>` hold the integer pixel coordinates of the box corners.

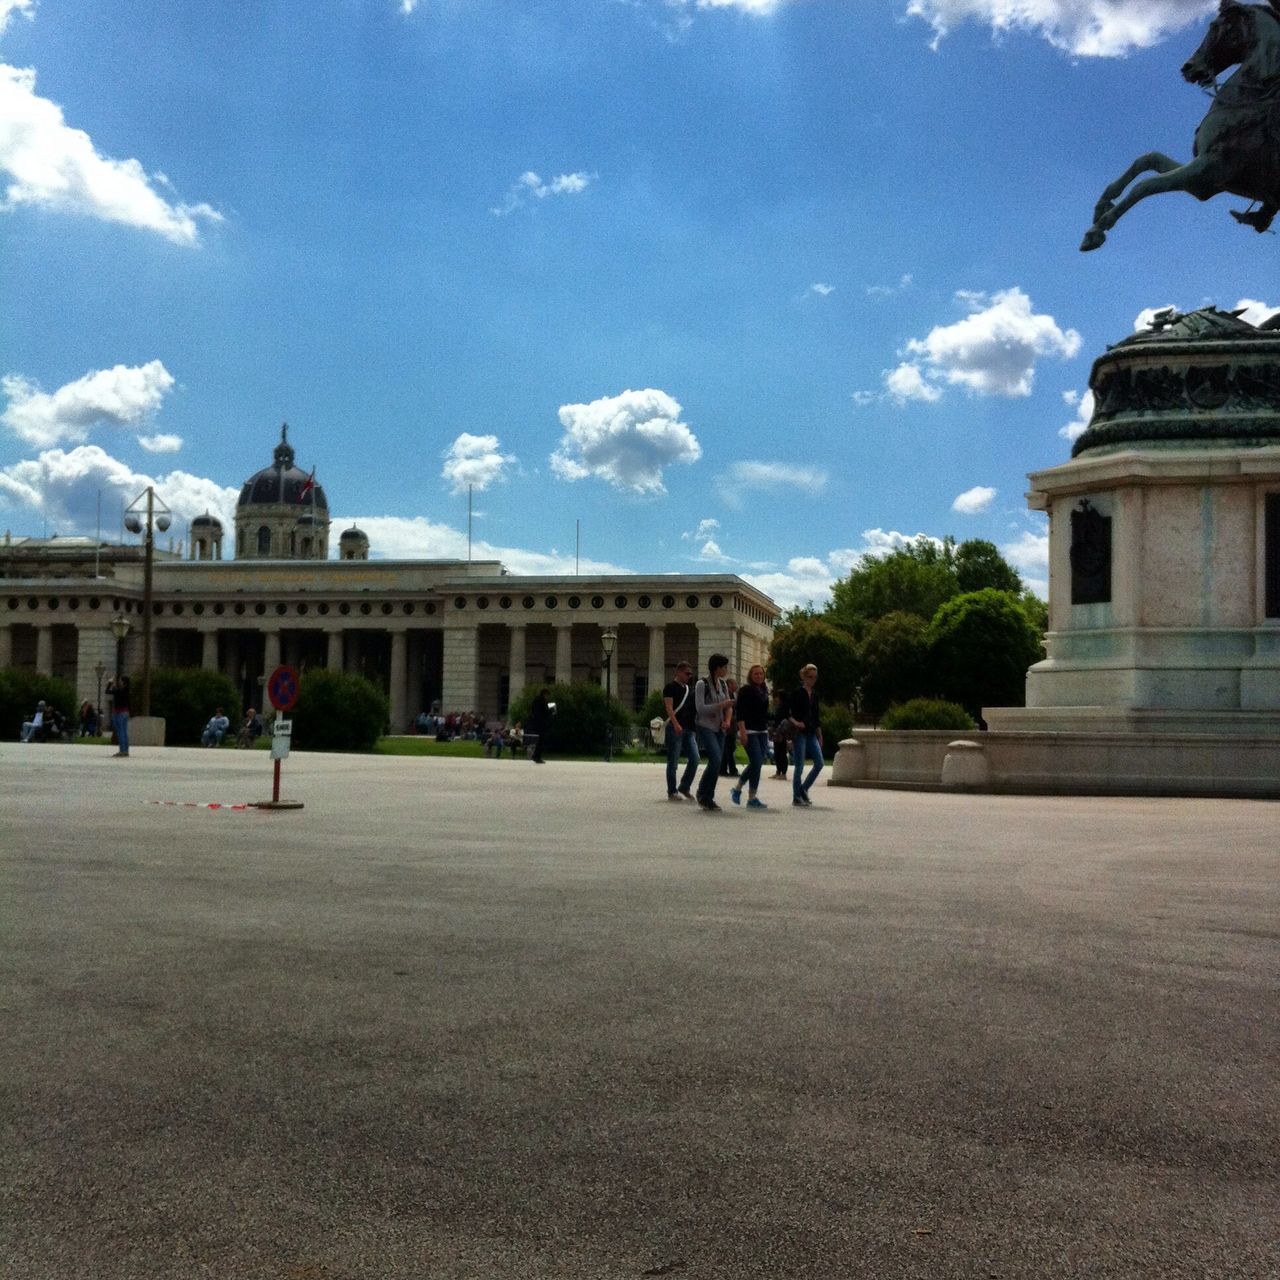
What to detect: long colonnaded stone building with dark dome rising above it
<box><xmin>0</xmin><ymin>430</ymin><xmax>778</xmax><ymax>732</ymax></box>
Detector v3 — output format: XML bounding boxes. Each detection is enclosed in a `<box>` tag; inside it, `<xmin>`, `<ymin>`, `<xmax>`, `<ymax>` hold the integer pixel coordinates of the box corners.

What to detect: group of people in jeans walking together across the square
<box><xmin>662</xmin><ymin>653</ymin><xmax>824</xmax><ymax>809</ymax></box>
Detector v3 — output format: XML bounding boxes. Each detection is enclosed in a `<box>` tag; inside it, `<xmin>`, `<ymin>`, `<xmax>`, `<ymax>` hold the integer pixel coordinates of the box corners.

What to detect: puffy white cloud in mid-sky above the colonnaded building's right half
<box><xmin>550</xmin><ymin>388</ymin><xmax>703</xmax><ymax>493</ymax></box>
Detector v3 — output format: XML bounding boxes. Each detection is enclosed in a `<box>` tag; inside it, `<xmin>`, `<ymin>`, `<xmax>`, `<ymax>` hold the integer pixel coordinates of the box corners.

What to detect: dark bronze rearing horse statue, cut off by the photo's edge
<box><xmin>1080</xmin><ymin>0</ymin><xmax>1280</xmax><ymax>251</ymax></box>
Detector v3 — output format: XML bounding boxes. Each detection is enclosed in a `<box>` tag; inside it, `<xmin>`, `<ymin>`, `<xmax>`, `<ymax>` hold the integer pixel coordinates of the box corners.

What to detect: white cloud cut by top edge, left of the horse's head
<box><xmin>906</xmin><ymin>0</ymin><xmax>1217</xmax><ymax>58</ymax></box>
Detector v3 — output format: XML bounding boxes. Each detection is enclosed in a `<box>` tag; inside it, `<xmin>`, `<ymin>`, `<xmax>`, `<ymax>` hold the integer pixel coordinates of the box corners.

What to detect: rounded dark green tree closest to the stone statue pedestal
<box><xmin>928</xmin><ymin>588</ymin><xmax>1043</xmax><ymax>719</ymax></box>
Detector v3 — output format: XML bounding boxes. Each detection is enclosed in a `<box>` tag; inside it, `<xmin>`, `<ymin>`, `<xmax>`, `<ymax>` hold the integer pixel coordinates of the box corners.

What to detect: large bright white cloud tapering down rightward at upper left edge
<box><xmin>0</xmin><ymin>64</ymin><xmax>223</xmax><ymax>246</ymax></box>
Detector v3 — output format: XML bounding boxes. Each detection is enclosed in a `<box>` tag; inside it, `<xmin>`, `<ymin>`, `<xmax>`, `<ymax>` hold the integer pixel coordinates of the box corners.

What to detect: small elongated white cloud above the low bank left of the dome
<box><xmin>0</xmin><ymin>360</ymin><xmax>173</xmax><ymax>445</ymax></box>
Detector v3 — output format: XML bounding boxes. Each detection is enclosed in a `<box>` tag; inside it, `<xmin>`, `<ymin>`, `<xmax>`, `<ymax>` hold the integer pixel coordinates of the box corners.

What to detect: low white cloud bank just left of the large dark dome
<box><xmin>0</xmin><ymin>444</ymin><xmax>239</xmax><ymax>531</ymax></box>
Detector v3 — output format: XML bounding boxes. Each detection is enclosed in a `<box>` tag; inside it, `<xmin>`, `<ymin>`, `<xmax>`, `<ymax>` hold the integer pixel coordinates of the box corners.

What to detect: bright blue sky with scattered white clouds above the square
<box><xmin>0</xmin><ymin>0</ymin><xmax>1280</xmax><ymax>607</ymax></box>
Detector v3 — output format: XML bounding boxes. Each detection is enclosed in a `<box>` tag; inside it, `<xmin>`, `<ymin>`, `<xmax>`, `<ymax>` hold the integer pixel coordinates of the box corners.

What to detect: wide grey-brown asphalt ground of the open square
<box><xmin>0</xmin><ymin>745</ymin><xmax>1280</xmax><ymax>1280</ymax></box>
